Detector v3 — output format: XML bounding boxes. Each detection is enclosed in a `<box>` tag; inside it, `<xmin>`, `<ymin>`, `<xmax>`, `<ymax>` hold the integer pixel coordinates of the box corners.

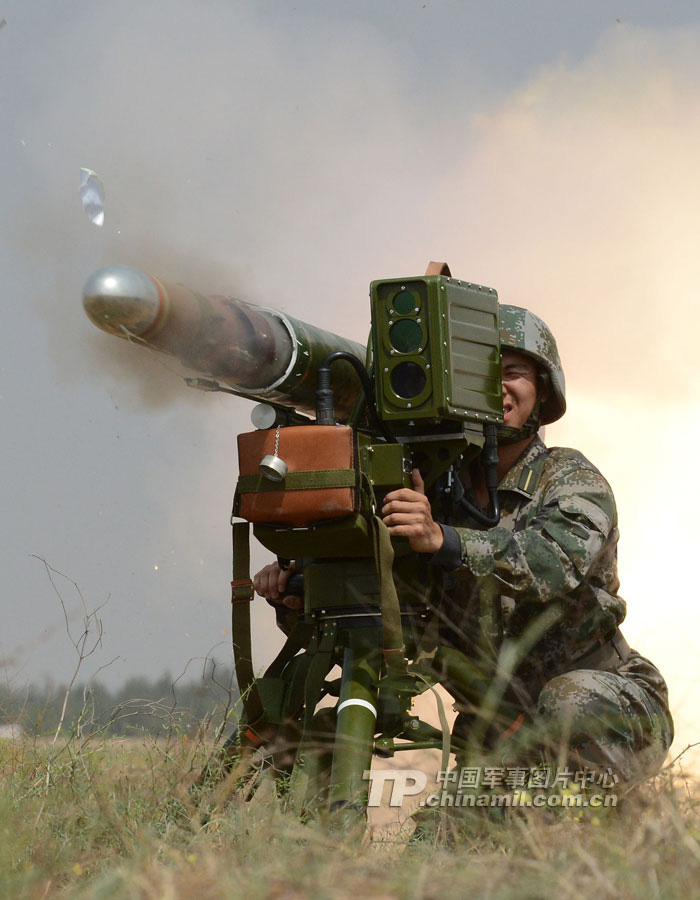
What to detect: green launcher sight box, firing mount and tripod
<box><xmin>234</xmin><ymin>275</ymin><xmax>503</xmax><ymax>828</ymax></box>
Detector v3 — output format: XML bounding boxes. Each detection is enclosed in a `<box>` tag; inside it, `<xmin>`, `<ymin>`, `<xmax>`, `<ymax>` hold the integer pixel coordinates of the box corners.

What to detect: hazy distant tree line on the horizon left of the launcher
<box><xmin>0</xmin><ymin>660</ymin><xmax>240</xmax><ymax>736</ymax></box>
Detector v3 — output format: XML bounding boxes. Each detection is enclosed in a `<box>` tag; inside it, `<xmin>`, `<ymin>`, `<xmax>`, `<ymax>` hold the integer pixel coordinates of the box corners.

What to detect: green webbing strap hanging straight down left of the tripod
<box><xmin>231</xmin><ymin>522</ymin><xmax>264</xmax><ymax>725</ymax></box>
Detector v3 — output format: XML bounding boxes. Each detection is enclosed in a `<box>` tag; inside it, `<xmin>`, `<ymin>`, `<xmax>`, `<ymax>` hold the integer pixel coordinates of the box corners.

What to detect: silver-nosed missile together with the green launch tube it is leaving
<box><xmin>83</xmin><ymin>265</ymin><xmax>365</xmax><ymax>421</ymax></box>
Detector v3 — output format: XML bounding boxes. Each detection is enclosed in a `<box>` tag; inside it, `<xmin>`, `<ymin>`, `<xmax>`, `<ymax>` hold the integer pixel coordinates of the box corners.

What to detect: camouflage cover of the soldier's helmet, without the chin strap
<box><xmin>499</xmin><ymin>303</ymin><xmax>566</xmax><ymax>425</ymax></box>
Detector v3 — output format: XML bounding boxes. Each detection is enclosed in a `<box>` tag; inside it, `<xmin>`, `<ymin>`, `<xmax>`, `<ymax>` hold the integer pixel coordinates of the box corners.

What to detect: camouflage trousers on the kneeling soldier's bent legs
<box><xmin>454</xmin><ymin>650</ymin><xmax>673</xmax><ymax>783</ymax></box>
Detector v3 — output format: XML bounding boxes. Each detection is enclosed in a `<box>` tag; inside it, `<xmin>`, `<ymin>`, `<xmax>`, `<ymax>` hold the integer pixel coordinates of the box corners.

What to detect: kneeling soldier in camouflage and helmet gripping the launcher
<box><xmin>382</xmin><ymin>305</ymin><xmax>673</xmax><ymax>781</ymax></box>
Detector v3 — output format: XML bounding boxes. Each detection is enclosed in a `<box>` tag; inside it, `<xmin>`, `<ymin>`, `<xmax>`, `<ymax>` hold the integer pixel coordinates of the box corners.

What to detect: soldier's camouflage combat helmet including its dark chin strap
<box><xmin>499</xmin><ymin>303</ymin><xmax>566</xmax><ymax>443</ymax></box>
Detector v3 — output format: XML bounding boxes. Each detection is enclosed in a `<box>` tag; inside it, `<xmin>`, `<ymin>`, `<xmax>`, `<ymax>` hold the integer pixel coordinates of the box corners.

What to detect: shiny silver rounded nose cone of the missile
<box><xmin>83</xmin><ymin>266</ymin><xmax>164</xmax><ymax>337</ymax></box>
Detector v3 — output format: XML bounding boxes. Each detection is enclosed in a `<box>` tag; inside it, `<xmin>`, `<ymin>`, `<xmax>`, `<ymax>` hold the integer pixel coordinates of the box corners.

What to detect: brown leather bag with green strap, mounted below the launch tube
<box><xmin>235</xmin><ymin>425</ymin><xmax>360</xmax><ymax>528</ymax></box>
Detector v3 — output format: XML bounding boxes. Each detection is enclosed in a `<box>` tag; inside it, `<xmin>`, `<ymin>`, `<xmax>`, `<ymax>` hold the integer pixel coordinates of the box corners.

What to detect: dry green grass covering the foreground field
<box><xmin>0</xmin><ymin>736</ymin><xmax>700</xmax><ymax>900</ymax></box>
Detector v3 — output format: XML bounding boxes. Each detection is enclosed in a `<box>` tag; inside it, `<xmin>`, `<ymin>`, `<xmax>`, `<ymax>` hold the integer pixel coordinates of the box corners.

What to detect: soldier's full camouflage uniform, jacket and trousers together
<box><xmin>431</xmin><ymin>437</ymin><xmax>673</xmax><ymax>780</ymax></box>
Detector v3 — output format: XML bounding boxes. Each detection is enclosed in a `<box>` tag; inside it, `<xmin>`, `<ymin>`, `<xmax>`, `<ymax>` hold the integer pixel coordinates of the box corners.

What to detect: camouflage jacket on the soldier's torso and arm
<box><xmin>431</xmin><ymin>437</ymin><xmax>626</xmax><ymax>695</ymax></box>
